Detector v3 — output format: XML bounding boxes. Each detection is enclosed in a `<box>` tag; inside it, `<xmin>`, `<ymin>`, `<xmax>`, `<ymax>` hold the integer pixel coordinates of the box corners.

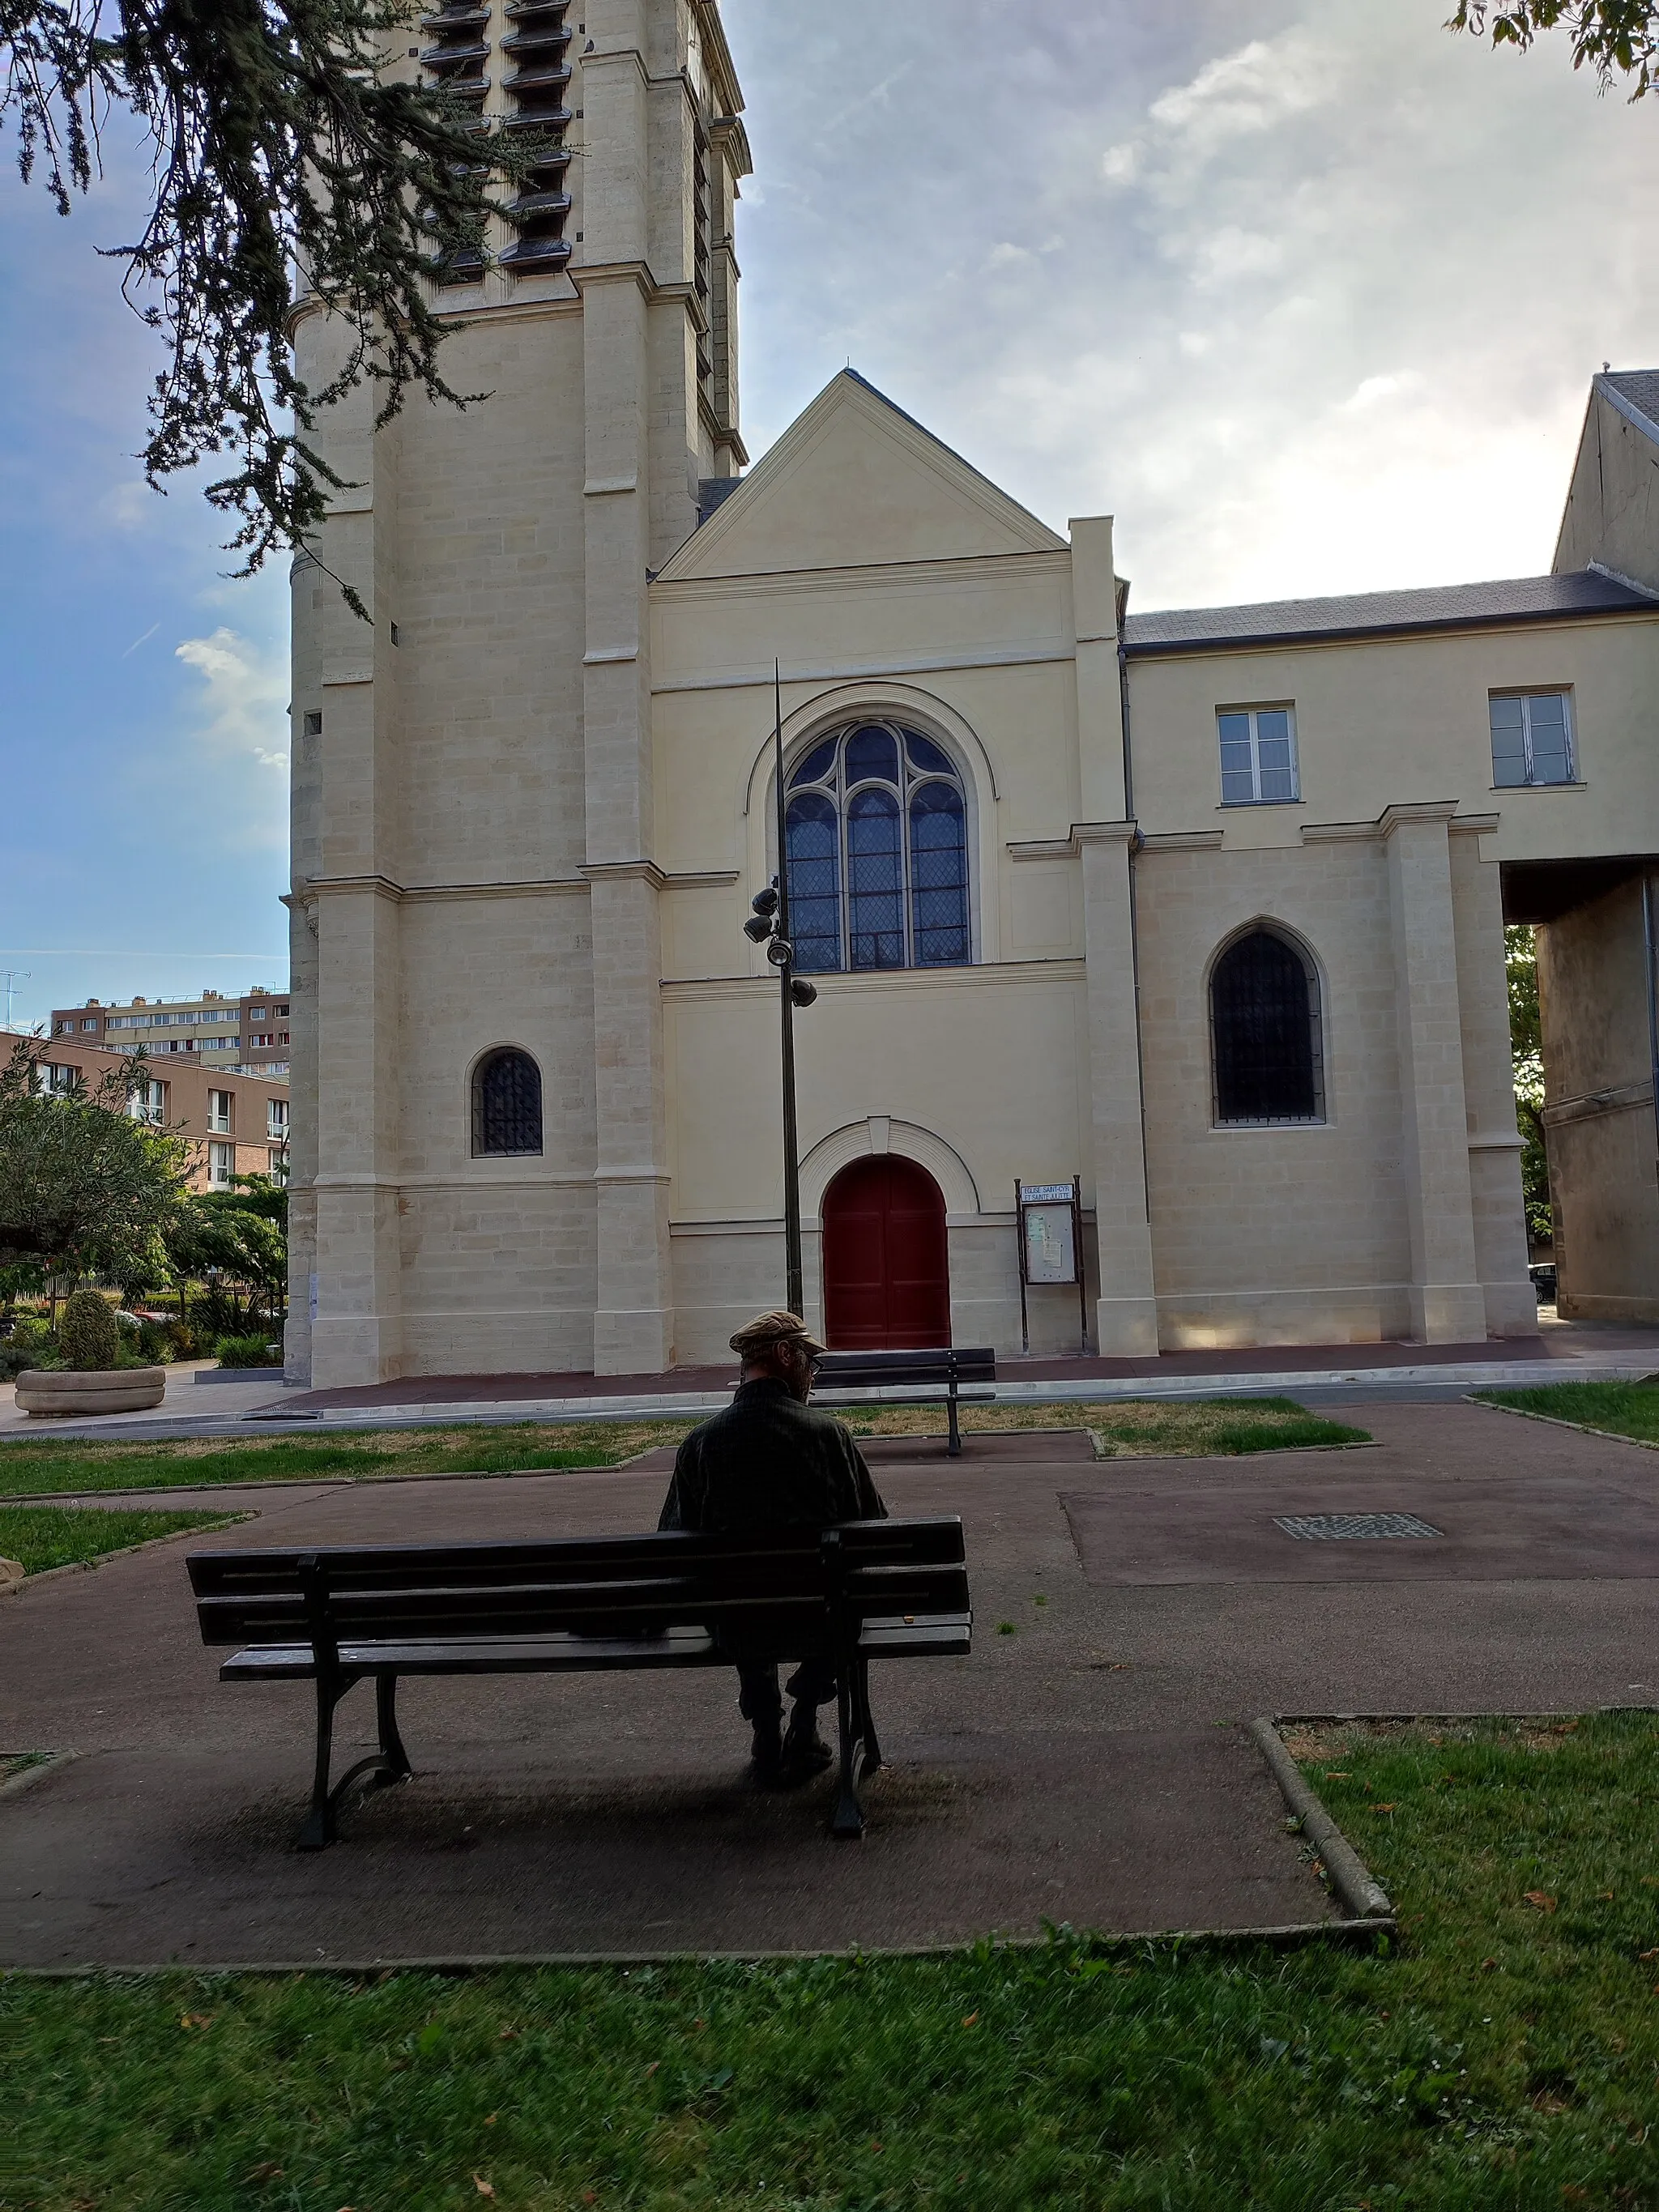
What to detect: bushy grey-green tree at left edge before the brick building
<box><xmin>0</xmin><ymin>1038</ymin><xmax>190</xmax><ymax>1283</ymax></box>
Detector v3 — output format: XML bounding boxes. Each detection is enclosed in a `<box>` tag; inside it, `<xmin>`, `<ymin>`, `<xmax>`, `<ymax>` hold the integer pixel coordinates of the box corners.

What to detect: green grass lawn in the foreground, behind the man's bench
<box><xmin>0</xmin><ymin>1715</ymin><xmax>1659</xmax><ymax>2212</ymax></box>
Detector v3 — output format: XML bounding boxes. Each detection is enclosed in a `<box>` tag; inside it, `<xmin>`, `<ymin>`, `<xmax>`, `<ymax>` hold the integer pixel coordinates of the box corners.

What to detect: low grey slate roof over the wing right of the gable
<box><xmin>1124</xmin><ymin>566</ymin><xmax>1659</xmax><ymax>659</ymax></box>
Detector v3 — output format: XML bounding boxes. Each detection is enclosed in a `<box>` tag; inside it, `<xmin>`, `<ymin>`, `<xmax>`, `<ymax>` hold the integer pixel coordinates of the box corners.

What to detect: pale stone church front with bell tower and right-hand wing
<box><xmin>288</xmin><ymin>0</ymin><xmax>1659</xmax><ymax>1385</ymax></box>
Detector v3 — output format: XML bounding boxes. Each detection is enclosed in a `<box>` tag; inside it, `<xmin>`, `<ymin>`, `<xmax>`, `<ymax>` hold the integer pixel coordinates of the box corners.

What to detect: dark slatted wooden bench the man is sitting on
<box><xmin>188</xmin><ymin>1515</ymin><xmax>973</xmax><ymax>1852</ymax></box>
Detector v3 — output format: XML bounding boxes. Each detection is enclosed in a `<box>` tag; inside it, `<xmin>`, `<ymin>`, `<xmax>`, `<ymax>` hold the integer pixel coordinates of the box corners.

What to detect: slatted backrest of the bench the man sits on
<box><xmin>188</xmin><ymin>1515</ymin><xmax>969</xmax><ymax>1646</ymax></box>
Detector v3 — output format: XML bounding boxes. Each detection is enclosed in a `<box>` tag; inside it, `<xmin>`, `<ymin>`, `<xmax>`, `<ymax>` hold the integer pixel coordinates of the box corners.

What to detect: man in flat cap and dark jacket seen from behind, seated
<box><xmin>657</xmin><ymin>1311</ymin><xmax>887</xmax><ymax>1788</ymax></box>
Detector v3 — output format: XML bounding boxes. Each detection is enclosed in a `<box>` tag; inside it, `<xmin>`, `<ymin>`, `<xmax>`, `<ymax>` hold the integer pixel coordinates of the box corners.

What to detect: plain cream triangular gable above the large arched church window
<box><xmin>661</xmin><ymin>369</ymin><xmax>1066</xmax><ymax>582</ymax></box>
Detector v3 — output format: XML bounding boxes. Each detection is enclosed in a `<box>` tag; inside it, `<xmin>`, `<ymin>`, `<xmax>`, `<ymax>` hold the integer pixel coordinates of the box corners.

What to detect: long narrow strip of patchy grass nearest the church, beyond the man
<box><xmin>0</xmin><ymin>1398</ymin><xmax>1365</xmax><ymax>1498</ymax></box>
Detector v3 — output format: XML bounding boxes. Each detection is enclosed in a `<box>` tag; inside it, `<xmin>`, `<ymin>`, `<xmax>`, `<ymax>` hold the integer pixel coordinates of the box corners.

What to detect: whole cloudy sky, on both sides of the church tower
<box><xmin>0</xmin><ymin>0</ymin><xmax>1659</xmax><ymax>1020</ymax></box>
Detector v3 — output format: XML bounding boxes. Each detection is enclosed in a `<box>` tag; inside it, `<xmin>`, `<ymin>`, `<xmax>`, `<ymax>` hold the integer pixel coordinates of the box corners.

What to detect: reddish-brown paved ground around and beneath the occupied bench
<box><xmin>0</xmin><ymin>1404</ymin><xmax>1659</xmax><ymax>1964</ymax></box>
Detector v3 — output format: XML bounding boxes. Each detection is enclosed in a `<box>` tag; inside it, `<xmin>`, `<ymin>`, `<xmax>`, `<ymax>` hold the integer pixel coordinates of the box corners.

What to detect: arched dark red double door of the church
<box><xmin>823</xmin><ymin>1153</ymin><xmax>951</xmax><ymax>1352</ymax></box>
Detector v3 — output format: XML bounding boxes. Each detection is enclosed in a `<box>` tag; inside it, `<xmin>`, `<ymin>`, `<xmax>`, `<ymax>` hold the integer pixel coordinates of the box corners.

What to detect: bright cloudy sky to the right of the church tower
<box><xmin>726</xmin><ymin>0</ymin><xmax>1659</xmax><ymax>606</ymax></box>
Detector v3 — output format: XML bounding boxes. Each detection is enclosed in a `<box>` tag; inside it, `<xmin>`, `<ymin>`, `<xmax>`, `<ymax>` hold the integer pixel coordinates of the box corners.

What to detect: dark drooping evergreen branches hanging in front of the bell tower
<box><xmin>0</xmin><ymin>0</ymin><xmax>544</xmax><ymax>612</ymax></box>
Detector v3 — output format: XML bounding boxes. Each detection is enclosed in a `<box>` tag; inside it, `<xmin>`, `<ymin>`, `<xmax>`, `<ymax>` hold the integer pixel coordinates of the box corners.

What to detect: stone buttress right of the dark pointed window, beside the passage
<box><xmin>1380</xmin><ymin>801</ymin><xmax>1486</xmax><ymax>1345</ymax></box>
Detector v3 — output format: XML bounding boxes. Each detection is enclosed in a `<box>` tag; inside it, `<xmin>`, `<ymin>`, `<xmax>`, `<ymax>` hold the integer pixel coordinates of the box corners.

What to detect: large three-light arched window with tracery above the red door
<box><xmin>787</xmin><ymin>721</ymin><xmax>973</xmax><ymax>975</ymax></box>
